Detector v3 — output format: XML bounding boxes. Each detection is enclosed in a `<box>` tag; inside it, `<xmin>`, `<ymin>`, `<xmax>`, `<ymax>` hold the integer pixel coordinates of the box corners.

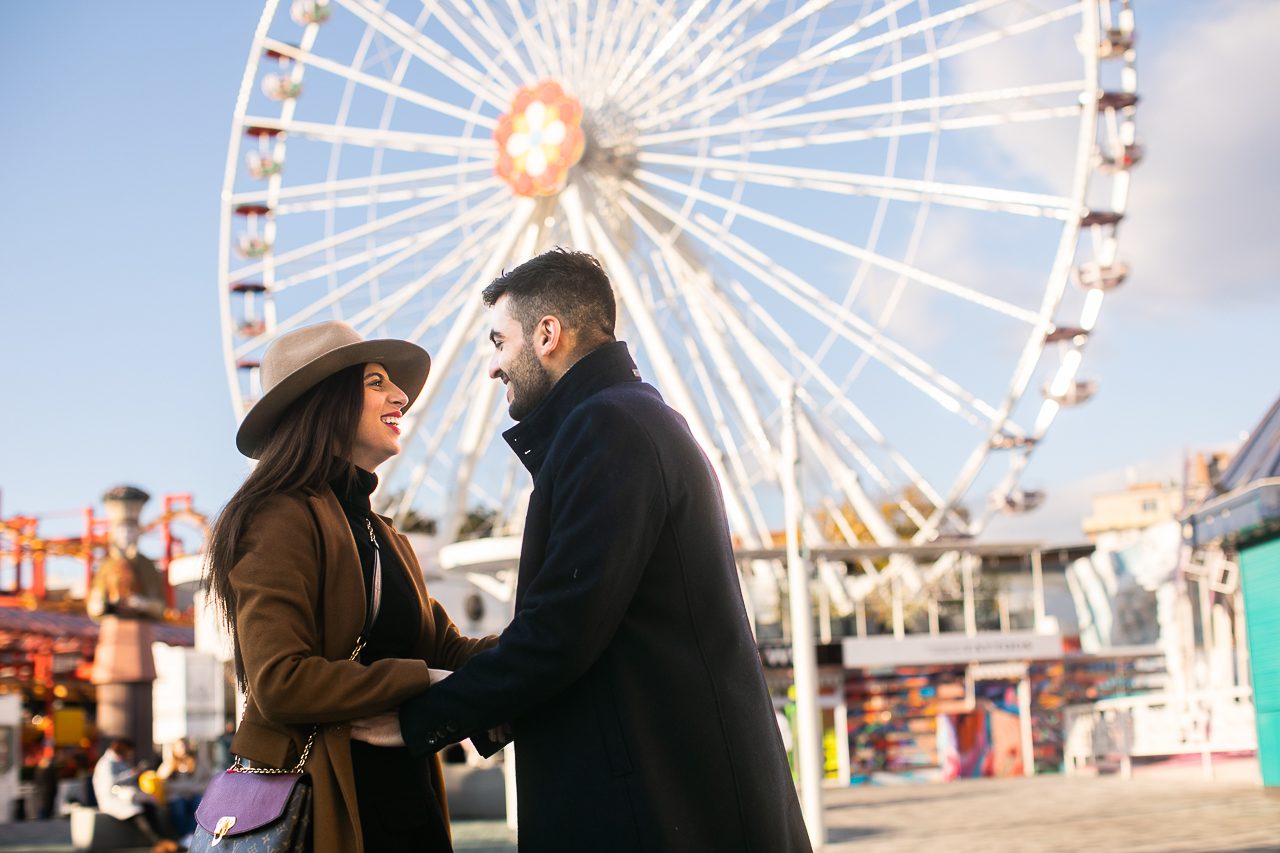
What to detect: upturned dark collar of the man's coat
<box><xmin>502</xmin><ymin>341</ymin><xmax>640</xmax><ymax>476</ymax></box>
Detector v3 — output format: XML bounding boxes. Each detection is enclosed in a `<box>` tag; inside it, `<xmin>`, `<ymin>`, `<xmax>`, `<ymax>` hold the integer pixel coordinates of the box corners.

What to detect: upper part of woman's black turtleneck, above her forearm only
<box><xmin>329</xmin><ymin>467</ymin><xmax>422</xmax><ymax>663</ymax></box>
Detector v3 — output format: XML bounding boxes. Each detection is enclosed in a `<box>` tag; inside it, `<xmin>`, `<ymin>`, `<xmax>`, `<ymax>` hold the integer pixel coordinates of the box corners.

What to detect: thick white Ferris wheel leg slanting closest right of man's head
<box><xmin>559</xmin><ymin>183</ymin><xmax>755</xmax><ymax>544</ymax></box>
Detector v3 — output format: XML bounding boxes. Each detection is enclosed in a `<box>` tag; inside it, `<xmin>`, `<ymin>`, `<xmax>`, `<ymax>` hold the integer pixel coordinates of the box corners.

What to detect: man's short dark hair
<box><xmin>483</xmin><ymin>246</ymin><xmax>617</xmax><ymax>346</ymax></box>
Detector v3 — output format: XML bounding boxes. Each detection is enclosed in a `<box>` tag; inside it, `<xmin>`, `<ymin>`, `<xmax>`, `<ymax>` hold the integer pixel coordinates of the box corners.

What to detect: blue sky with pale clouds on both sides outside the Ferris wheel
<box><xmin>0</xmin><ymin>0</ymin><xmax>1280</xmax><ymax>578</ymax></box>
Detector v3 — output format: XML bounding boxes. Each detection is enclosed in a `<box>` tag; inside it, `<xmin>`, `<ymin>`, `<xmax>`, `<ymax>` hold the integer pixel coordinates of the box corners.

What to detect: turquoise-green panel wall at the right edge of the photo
<box><xmin>1240</xmin><ymin>539</ymin><xmax>1280</xmax><ymax>788</ymax></box>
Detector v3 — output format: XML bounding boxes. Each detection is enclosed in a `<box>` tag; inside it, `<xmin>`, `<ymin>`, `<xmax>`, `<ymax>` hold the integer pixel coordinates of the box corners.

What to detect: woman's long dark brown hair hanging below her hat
<box><xmin>204</xmin><ymin>364</ymin><xmax>365</xmax><ymax>686</ymax></box>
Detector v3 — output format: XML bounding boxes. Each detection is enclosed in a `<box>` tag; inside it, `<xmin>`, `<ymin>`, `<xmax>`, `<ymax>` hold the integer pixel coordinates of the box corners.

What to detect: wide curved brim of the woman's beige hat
<box><xmin>236</xmin><ymin>339</ymin><xmax>431</xmax><ymax>459</ymax></box>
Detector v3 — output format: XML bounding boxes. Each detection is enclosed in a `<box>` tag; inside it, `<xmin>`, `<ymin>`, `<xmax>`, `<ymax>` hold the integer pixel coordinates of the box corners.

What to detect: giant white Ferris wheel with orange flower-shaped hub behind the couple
<box><xmin>219</xmin><ymin>0</ymin><xmax>1140</xmax><ymax>596</ymax></box>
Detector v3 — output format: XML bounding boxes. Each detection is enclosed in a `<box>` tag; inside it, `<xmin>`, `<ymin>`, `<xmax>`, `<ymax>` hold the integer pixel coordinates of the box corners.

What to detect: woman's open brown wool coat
<box><xmin>230</xmin><ymin>487</ymin><xmax>495</xmax><ymax>853</ymax></box>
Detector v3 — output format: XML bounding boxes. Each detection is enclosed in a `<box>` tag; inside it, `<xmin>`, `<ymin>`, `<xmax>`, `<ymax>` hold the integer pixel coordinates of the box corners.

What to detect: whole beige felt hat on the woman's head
<box><xmin>236</xmin><ymin>320</ymin><xmax>431</xmax><ymax>459</ymax></box>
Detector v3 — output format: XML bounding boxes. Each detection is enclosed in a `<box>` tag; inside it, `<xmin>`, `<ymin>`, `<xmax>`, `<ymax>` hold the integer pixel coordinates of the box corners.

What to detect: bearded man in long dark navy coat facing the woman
<box><xmin>353</xmin><ymin>250</ymin><xmax>810</xmax><ymax>853</ymax></box>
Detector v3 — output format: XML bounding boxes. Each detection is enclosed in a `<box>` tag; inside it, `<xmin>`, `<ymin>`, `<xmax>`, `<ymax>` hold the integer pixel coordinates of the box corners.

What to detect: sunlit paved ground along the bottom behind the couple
<box><xmin>0</xmin><ymin>761</ymin><xmax>1280</xmax><ymax>853</ymax></box>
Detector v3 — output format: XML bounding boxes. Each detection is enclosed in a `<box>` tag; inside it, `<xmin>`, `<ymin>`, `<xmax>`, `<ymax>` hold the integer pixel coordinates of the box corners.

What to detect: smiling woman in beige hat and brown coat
<box><xmin>206</xmin><ymin>323</ymin><xmax>494</xmax><ymax>853</ymax></box>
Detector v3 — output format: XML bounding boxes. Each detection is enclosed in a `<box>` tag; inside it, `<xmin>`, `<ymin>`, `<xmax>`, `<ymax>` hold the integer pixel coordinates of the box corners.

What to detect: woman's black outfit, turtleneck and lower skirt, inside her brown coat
<box><xmin>329</xmin><ymin>467</ymin><xmax>453</xmax><ymax>853</ymax></box>
